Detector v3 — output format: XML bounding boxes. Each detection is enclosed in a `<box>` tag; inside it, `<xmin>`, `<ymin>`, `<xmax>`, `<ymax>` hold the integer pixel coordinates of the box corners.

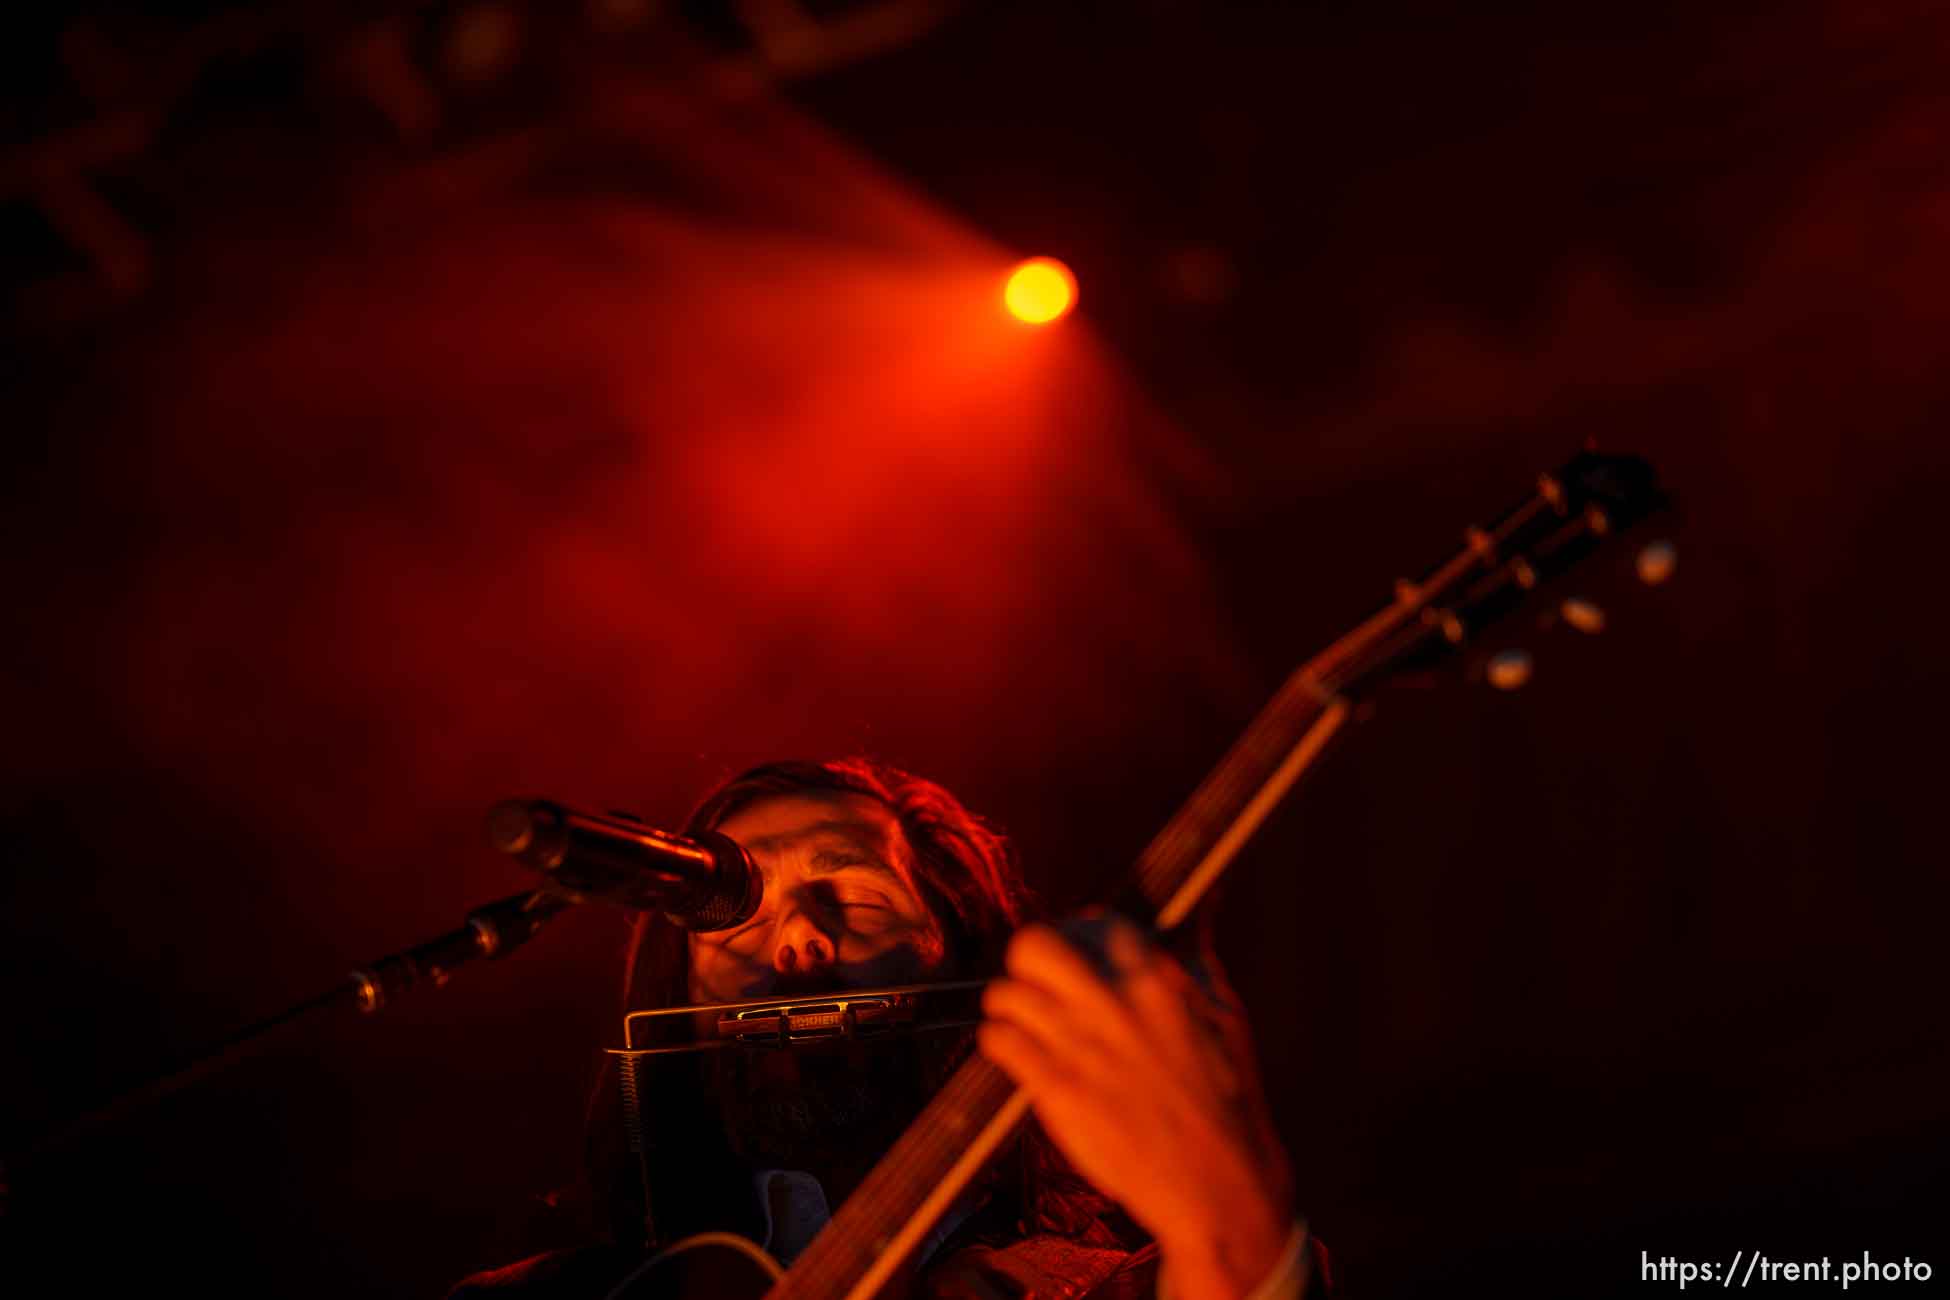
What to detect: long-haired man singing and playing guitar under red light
<box><xmin>450</xmin><ymin>758</ymin><xmax>1324</xmax><ymax>1300</ymax></box>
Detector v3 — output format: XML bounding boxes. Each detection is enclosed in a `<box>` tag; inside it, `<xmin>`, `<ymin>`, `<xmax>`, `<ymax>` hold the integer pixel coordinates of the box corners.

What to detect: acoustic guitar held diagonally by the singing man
<box><xmin>608</xmin><ymin>450</ymin><xmax>1673</xmax><ymax>1300</ymax></box>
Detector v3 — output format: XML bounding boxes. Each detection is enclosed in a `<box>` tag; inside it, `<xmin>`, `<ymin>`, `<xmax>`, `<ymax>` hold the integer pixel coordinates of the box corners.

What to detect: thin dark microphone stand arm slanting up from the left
<box><xmin>11</xmin><ymin>891</ymin><xmax>571</xmax><ymax>1161</ymax></box>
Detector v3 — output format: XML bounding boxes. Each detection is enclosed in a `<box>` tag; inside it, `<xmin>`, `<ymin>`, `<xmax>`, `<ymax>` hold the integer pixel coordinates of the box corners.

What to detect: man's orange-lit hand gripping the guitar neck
<box><xmin>977</xmin><ymin>918</ymin><xmax>1295</xmax><ymax>1300</ymax></box>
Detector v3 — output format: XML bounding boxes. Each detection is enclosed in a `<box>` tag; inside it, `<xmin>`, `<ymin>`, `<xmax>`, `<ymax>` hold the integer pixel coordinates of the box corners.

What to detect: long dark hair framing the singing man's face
<box><xmin>587</xmin><ymin>756</ymin><xmax>1123</xmax><ymax>1245</ymax></box>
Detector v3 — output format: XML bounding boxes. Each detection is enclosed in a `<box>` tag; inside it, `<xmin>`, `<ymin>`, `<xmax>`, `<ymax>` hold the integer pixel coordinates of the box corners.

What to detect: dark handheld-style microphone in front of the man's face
<box><xmin>488</xmin><ymin>799</ymin><xmax>764</xmax><ymax>930</ymax></box>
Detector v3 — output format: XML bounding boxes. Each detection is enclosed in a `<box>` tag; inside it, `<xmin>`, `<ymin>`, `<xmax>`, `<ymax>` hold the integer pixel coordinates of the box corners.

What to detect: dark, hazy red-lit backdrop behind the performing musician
<box><xmin>0</xmin><ymin>0</ymin><xmax>1950</xmax><ymax>1296</ymax></box>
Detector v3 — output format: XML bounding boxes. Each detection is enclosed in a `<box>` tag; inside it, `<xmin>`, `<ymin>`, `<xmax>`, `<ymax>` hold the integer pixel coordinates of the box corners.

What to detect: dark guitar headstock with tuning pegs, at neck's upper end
<box><xmin>1308</xmin><ymin>448</ymin><xmax>1675</xmax><ymax>696</ymax></box>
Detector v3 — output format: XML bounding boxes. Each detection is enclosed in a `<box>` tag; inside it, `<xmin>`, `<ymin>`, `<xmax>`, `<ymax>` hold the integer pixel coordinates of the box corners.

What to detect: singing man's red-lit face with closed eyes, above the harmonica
<box><xmin>690</xmin><ymin>791</ymin><xmax>946</xmax><ymax>1002</ymax></box>
